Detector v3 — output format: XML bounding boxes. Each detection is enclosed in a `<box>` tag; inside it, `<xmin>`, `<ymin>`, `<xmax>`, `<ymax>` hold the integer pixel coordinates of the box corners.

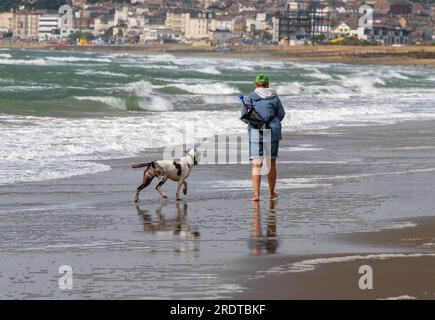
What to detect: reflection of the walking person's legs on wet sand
<box><xmin>249</xmin><ymin>200</ymin><xmax>278</xmax><ymax>256</ymax></box>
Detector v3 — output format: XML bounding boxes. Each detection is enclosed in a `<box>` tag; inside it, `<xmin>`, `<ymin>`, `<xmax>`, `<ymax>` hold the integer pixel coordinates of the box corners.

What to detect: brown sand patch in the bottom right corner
<box><xmin>235</xmin><ymin>217</ymin><xmax>435</xmax><ymax>300</ymax></box>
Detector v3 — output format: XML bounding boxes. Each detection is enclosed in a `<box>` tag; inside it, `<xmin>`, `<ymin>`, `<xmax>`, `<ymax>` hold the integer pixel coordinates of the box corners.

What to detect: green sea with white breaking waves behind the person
<box><xmin>0</xmin><ymin>50</ymin><xmax>435</xmax><ymax>184</ymax></box>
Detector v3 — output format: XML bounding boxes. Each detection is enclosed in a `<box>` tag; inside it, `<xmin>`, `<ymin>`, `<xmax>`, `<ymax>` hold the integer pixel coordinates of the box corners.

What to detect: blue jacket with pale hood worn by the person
<box><xmin>242</xmin><ymin>88</ymin><xmax>285</xmax><ymax>142</ymax></box>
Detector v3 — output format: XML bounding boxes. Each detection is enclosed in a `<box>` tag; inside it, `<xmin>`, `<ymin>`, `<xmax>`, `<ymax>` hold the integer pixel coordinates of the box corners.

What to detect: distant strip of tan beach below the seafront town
<box><xmin>0</xmin><ymin>44</ymin><xmax>435</xmax><ymax>67</ymax></box>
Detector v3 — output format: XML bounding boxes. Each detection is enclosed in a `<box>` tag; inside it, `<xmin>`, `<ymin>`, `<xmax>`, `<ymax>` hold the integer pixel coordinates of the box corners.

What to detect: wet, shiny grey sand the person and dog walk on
<box><xmin>0</xmin><ymin>121</ymin><xmax>435</xmax><ymax>299</ymax></box>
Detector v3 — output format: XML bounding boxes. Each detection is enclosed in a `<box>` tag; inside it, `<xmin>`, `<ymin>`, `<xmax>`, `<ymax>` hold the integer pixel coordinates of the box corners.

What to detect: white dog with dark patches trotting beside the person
<box><xmin>131</xmin><ymin>149</ymin><xmax>201</xmax><ymax>203</ymax></box>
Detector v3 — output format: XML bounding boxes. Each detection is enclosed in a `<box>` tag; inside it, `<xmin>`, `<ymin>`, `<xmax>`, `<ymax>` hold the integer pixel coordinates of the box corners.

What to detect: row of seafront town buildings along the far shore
<box><xmin>0</xmin><ymin>0</ymin><xmax>435</xmax><ymax>46</ymax></box>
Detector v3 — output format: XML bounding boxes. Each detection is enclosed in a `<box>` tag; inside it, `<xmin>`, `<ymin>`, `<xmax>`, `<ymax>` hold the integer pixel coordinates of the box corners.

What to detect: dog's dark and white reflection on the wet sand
<box><xmin>136</xmin><ymin>201</ymin><xmax>200</xmax><ymax>239</ymax></box>
